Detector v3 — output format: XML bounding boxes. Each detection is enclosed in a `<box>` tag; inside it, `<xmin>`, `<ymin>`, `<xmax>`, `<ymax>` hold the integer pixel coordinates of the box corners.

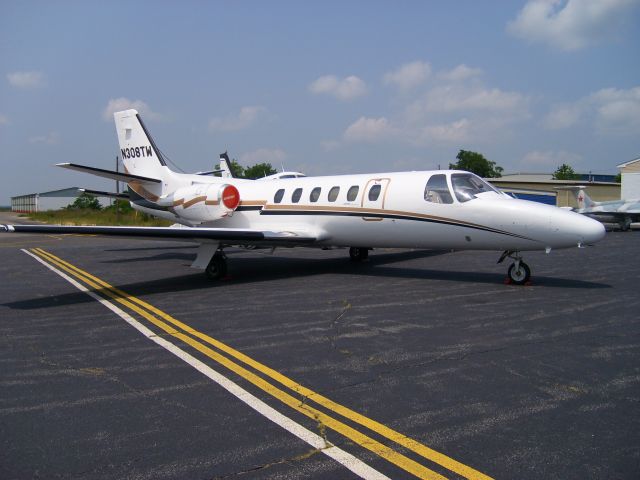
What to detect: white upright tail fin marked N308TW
<box><xmin>113</xmin><ymin>110</ymin><xmax>169</xmax><ymax>178</ymax></box>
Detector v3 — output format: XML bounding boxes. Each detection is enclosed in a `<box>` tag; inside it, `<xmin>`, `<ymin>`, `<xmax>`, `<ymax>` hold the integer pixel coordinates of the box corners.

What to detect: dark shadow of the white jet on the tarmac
<box><xmin>2</xmin><ymin>250</ymin><xmax>611</xmax><ymax>310</ymax></box>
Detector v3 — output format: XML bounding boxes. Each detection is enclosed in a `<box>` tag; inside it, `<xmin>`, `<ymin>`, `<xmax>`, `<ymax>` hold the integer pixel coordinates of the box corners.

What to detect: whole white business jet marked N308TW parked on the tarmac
<box><xmin>4</xmin><ymin>110</ymin><xmax>605</xmax><ymax>284</ymax></box>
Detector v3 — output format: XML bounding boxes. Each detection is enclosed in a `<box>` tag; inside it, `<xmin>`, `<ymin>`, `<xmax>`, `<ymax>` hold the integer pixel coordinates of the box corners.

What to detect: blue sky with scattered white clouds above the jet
<box><xmin>0</xmin><ymin>0</ymin><xmax>640</xmax><ymax>205</ymax></box>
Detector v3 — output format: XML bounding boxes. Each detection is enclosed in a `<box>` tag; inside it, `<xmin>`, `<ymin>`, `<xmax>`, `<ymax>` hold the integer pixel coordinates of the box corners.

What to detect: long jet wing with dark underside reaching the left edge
<box><xmin>0</xmin><ymin>225</ymin><xmax>320</xmax><ymax>246</ymax></box>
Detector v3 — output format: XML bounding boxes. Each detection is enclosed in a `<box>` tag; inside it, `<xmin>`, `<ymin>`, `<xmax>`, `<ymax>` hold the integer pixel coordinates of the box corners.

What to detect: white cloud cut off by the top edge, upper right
<box><xmin>507</xmin><ymin>0</ymin><xmax>639</xmax><ymax>51</ymax></box>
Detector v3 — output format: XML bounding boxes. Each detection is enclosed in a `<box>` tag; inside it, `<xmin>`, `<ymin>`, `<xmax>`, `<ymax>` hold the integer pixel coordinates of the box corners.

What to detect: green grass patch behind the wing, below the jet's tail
<box><xmin>21</xmin><ymin>209</ymin><xmax>172</xmax><ymax>227</ymax></box>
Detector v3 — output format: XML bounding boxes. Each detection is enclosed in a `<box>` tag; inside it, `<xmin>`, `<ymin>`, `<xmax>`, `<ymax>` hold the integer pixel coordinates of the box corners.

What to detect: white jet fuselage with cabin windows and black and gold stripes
<box><xmin>132</xmin><ymin>169</ymin><xmax>602</xmax><ymax>251</ymax></box>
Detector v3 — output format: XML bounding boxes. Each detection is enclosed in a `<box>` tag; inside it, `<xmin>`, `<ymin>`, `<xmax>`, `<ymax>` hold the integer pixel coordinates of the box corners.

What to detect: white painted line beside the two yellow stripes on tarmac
<box><xmin>22</xmin><ymin>249</ymin><xmax>391</xmax><ymax>480</ymax></box>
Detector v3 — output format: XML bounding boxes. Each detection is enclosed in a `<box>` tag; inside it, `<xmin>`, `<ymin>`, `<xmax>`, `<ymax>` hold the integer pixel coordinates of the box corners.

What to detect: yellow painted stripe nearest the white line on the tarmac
<box><xmin>31</xmin><ymin>248</ymin><xmax>446</xmax><ymax>480</ymax></box>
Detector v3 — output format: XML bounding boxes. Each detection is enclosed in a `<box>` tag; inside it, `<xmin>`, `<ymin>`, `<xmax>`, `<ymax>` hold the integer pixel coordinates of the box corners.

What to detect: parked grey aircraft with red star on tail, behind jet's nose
<box><xmin>558</xmin><ymin>185</ymin><xmax>640</xmax><ymax>231</ymax></box>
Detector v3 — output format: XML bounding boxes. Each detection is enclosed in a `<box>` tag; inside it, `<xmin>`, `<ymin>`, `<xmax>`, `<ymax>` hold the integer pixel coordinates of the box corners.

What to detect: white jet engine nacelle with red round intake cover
<box><xmin>173</xmin><ymin>184</ymin><xmax>240</xmax><ymax>223</ymax></box>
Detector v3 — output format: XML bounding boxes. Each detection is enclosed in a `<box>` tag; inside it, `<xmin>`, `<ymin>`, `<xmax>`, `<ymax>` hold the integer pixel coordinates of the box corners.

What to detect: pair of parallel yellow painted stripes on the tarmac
<box><xmin>31</xmin><ymin>248</ymin><xmax>491</xmax><ymax>480</ymax></box>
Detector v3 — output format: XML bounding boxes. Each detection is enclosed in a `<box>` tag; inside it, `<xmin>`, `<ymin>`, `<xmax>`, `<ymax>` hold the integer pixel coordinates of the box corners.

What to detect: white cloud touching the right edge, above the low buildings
<box><xmin>544</xmin><ymin>86</ymin><xmax>640</xmax><ymax>135</ymax></box>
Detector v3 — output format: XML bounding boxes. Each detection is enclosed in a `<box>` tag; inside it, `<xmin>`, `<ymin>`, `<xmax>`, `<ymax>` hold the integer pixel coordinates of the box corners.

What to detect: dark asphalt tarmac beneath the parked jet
<box><xmin>0</xmin><ymin>214</ymin><xmax>640</xmax><ymax>480</ymax></box>
